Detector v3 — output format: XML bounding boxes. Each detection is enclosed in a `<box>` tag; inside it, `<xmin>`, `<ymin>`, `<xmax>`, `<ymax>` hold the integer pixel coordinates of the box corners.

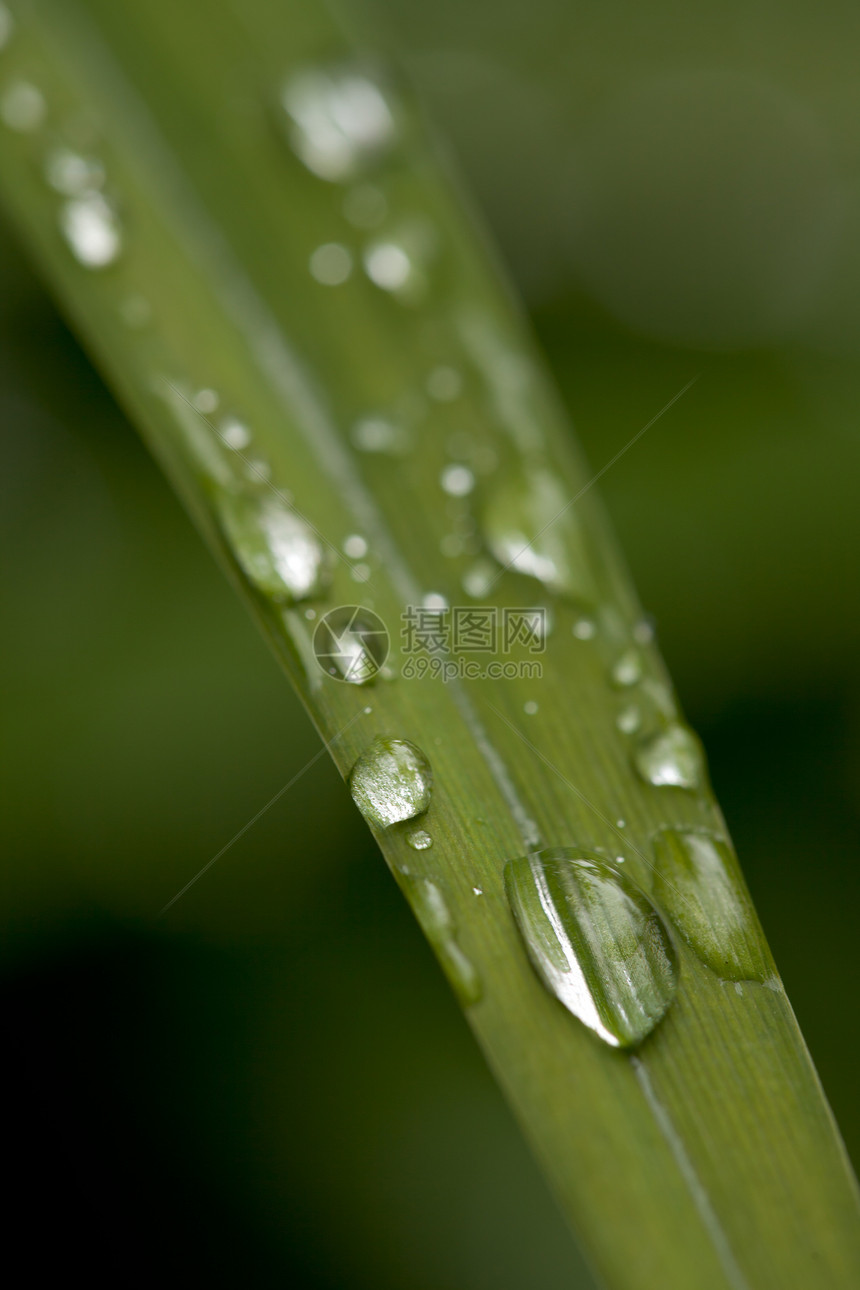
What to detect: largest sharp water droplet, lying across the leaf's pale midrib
<box><xmin>504</xmin><ymin>848</ymin><xmax>677</xmax><ymax>1047</ymax></box>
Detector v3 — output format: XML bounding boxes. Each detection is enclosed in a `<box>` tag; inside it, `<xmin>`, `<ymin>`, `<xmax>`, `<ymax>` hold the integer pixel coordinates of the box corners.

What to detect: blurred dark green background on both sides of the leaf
<box><xmin>0</xmin><ymin>0</ymin><xmax>860</xmax><ymax>1290</ymax></box>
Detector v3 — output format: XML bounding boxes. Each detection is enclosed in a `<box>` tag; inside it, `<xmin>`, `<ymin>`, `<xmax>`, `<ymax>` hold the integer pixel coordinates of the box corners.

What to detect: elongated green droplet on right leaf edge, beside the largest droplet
<box><xmin>654</xmin><ymin>828</ymin><xmax>772</xmax><ymax>980</ymax></box>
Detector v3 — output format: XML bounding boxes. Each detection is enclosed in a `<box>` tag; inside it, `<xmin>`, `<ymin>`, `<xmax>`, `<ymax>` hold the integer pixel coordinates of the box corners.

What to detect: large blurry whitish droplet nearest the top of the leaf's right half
<box><xmin>281</xmin><ymin>67</ymin><xmax>397</xmax><ymax>182</ymax></box>
